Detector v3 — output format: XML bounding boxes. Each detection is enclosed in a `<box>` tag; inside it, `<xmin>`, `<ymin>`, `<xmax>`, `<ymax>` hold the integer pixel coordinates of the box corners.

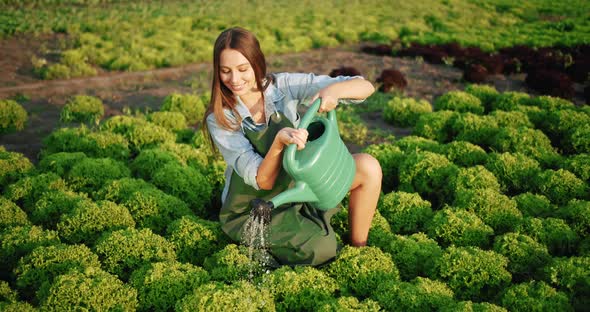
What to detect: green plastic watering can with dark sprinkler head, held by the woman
<box><xmin>250</xmin><ymin>99</ymin><xmax>356</xmax><ymax>222</ymax></box>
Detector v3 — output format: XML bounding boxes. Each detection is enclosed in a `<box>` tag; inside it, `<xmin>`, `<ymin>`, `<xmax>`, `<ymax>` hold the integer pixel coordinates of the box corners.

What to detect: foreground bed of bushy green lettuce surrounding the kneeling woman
<box><xmin>0</xmin><ymin>85</ymin><xmax>590</xmax><ymax>311</ymax></box>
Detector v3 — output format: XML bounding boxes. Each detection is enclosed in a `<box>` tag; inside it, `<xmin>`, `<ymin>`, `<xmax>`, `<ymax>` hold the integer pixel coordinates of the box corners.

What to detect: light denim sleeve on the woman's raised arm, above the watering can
<box><xmin>281</xmin><ymin>73</ymin><xmax>364</xmax><ymax>104</ymax></box>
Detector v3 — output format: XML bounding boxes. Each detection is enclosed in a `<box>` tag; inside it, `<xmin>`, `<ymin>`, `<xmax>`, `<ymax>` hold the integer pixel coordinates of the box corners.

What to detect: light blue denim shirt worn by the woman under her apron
<box><xmin>207</xmin><ymin>73</ymin><xmax>364</xmax><ymax>202</ymax></box>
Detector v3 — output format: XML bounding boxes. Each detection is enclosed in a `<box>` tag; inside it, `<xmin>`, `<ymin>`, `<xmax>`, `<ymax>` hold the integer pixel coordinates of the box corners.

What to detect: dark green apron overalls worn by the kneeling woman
<box><xmin>219</xmin><ymin>112</ymin><xmax>339</xmax><ymax>265</ymax></box>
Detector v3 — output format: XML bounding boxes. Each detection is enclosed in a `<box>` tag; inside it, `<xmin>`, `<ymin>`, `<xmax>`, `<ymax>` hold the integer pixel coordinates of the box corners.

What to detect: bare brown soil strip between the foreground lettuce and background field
<box><xmin>0</xmin><ymin>37</ymin><xmax>581</xmax><ymax>161</ymax></box>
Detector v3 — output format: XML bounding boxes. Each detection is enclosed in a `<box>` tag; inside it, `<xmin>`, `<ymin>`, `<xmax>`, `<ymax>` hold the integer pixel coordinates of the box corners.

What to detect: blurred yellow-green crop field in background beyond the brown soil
<box><xmin>0</xmin><ymin>0</ymin><xmax>590</xmax><ymax>79</ymax></box>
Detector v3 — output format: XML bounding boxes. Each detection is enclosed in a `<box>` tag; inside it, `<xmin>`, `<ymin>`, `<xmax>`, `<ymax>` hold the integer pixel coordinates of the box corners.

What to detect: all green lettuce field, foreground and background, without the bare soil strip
<box><xmin>0</xmin><ymin>0</ymin><xmax>590</xmax><ymax>311</ymax></box>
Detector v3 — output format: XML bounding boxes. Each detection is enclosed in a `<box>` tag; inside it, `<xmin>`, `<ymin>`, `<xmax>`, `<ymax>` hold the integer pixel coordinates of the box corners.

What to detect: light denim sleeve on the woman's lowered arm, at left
<box><xmin>207</xmin><ymin>114</ymin><xmax>262</xmax><ymax>190</ymax></box>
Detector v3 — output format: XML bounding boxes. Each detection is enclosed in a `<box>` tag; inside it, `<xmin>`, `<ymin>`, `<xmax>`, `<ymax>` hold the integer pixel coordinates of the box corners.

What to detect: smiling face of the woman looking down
<box><xmin>219</xmin><ymin>49</ymin><xmax>256</xmax><ymax>96</ymax></box>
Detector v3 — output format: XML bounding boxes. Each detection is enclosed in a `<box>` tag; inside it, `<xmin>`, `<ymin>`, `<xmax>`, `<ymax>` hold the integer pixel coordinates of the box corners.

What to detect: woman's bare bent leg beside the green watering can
<box><xmin>348</xmin><ymin>154</ymin><xmax>383</xmax><ymax>246</ymax></box>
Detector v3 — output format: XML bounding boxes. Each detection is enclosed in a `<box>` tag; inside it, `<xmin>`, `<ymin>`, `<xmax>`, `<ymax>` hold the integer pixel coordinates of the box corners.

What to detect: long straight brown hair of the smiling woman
<box><xmin>202</xmin><ymin>27</ymin><xmax>271</xmax><ymax>147</ymax></box>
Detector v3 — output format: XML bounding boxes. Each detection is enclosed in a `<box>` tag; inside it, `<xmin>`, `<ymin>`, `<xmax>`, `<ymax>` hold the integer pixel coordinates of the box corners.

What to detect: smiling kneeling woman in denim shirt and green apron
<box><xmin>204</xmin><ymin>28</ymin><xmax>381</xmax><ymax>265</ymax></box>
